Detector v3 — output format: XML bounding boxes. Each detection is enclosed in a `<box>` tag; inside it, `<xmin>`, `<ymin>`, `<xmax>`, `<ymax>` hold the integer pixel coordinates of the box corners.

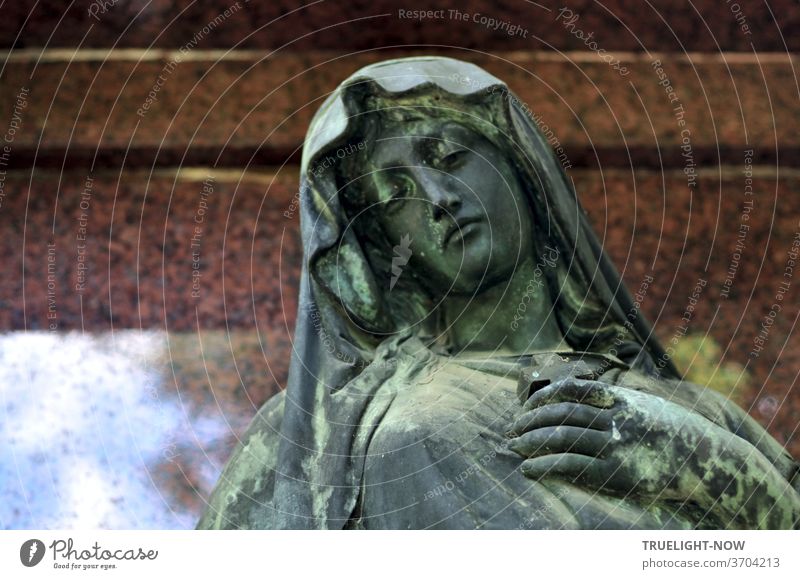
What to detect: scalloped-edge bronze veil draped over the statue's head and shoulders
<box><xmin>270</xmin><ymin>57</ymin><xmax>679</xmax><ymax>528</ymax></box>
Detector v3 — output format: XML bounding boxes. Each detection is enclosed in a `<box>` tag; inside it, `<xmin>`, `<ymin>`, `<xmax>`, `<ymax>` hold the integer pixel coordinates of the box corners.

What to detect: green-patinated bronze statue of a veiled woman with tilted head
<box><xmin>198</xmin><ymin>57</ymin><xmax>800</xmax><ymax>529</ymax></box>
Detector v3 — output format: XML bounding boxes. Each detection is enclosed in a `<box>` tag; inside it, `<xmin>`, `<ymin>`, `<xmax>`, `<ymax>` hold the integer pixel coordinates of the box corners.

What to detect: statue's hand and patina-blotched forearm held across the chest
<box><xmin>509</xmin><ymin>378</ymin><xmax>800</xmax><ymax>529</ymax></box>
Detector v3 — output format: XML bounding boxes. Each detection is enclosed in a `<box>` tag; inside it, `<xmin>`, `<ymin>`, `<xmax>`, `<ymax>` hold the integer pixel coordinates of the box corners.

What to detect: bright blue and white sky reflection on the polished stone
<box><xmin>0</xmin><ymin>331</ymin><xmax>226</xmax><ymax>529</ymax></box>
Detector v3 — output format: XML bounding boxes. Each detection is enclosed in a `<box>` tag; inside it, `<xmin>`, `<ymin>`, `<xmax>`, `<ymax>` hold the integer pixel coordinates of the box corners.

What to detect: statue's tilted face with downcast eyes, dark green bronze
<box><xmin>360</xmin><ymin>120</ymin><xmax>532</xmax><ymax>295</ymax></box>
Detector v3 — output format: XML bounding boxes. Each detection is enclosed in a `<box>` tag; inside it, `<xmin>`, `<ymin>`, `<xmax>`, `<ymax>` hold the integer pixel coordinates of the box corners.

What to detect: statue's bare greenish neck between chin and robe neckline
<box><xmin>443</xmin><ymin>257</ymin><xmax>570</xmax><ymax>354</ymax></box>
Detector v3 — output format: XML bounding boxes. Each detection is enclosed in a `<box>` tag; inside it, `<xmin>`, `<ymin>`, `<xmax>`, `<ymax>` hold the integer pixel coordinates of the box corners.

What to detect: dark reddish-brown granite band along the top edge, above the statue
<box><xmin>0</xmin><ymin>0</ymin><xmax>800</xmax><ymax>52</ymax></box>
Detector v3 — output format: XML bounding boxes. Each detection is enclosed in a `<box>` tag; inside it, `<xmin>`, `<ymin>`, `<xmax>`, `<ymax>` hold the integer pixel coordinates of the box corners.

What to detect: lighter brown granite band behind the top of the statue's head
<box><xmin>0</xmin><ymin>50</ymin><xmax>800</xmax><ymax>170</ymax></box>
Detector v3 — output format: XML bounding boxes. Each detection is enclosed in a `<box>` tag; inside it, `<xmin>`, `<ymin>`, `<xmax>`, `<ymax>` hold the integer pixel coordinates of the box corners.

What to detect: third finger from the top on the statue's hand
<box><xmin>508</xmin><ymin>425</ymin><xmax>612</xmax><ymax>458</ymax></box>
